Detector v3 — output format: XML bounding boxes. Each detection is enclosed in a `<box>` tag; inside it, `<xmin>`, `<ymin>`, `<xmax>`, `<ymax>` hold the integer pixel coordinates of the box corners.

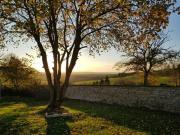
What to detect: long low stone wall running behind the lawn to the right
<box><xmin>66</xmin><ymin>86</ymin><xmax>180</xmax><ymax>114</ymax></box>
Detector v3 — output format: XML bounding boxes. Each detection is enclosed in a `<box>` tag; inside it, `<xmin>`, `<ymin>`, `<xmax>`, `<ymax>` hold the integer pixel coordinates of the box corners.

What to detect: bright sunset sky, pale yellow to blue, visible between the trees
<box><xmin>2</xmin><ymin>6</ymin><xmax>180</xmax><ymax>72</ymax></box>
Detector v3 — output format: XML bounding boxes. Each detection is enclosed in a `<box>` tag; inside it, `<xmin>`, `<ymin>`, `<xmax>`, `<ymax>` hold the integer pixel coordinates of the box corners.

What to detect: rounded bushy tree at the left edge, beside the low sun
<box><xmin>0</xmin><ymin>54</ymin><xmax>33</xmax><ymax>90</ymax></box>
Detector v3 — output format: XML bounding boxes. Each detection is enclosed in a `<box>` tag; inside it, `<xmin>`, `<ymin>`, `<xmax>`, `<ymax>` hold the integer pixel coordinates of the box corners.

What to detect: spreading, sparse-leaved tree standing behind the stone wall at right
<box><xmin>116</xmin><ymin>34</ymin><xmax>179</xmax><ymax>86</ymax></box>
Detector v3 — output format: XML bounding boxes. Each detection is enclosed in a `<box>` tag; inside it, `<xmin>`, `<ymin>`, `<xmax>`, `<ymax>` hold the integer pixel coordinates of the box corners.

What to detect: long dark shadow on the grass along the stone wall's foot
<box><xmin>64</xmin><ymin>100</ymin><xmax>180</xmax><ymax>135</ymax></box>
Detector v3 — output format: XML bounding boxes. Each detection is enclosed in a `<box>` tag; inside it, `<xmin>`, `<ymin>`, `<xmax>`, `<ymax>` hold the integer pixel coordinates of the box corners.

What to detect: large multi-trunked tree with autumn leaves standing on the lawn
<box><xmin>0</xmin><ymin>0</ymin><xmax>177</xmax><ymax>110</ymax></box>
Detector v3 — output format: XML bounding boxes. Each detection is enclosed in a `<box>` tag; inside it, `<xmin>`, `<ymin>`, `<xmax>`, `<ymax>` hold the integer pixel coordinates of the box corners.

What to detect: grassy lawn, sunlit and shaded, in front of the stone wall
<box><xmin>0</xmin><ymin>97</ymin><xmax>180</xmax><ymax>135</ymax></box>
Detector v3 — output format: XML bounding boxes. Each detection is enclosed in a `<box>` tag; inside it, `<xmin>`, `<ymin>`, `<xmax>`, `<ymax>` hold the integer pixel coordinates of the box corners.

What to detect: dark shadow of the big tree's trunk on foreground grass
<box><xmin>46</xmin><ymin>117</ymin><xmax>70</xmax><ymax>135</ymax></box>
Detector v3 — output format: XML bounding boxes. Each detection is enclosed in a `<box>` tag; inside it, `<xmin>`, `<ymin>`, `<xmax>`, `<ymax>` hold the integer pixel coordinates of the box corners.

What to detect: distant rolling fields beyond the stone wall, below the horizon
<box><xmin>26</xmin><ymin>71</ymin><xmax>179</xmax><ymax>86</ymax></box>
